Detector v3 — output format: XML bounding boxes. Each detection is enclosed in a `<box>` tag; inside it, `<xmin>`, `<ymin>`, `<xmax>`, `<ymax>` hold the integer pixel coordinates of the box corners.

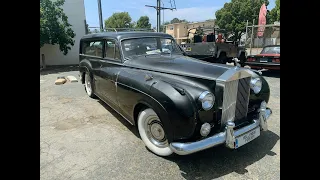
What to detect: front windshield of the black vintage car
<box><xmin>121</xmin><ymin>37</ymin><xmax>182</xmax><ymax>58</ymax></box>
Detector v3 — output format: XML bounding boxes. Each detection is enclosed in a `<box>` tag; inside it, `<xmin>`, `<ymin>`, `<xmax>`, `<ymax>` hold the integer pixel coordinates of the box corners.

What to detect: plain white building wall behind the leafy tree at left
<box><xmin>40</xmin><ymin>0</ymin><xmax>86</xmax><ymax>65</ymax></box>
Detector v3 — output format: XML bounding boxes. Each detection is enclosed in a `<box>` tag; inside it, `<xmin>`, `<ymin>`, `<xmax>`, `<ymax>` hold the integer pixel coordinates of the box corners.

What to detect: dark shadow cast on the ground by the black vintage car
<box><xmin>98</xmin><ymin>97</ymin><xmax>280</xmax><ymax>180</ymax></box>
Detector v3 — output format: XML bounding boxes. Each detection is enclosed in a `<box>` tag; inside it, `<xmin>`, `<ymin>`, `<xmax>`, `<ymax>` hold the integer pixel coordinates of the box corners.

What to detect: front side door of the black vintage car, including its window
<box><xmin>99</xmin><ymin>39</ymin><xmax>122</xmax><ymax>109</ymax></box>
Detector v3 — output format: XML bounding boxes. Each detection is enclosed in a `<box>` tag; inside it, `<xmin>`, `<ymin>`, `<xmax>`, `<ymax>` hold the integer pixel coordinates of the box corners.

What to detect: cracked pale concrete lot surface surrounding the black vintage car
<box><xmin>40</xmin><ymin>68</ymin><xmax>280</xmax><ymax>180</ymax></box>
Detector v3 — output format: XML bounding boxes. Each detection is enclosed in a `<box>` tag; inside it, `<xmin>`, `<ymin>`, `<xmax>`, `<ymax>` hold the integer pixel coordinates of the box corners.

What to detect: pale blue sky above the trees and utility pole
<box><xmin>84</xmin><ymin>0</ymin><xmax>275</xmax><ymax>27</ymax></box>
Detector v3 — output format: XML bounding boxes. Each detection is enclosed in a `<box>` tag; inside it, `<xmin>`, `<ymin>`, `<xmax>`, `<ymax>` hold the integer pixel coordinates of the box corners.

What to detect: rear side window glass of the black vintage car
<box><xmin>82</xmin><ymin>41</ymin><xmax>103</xmax><ymax>57</ymax></box>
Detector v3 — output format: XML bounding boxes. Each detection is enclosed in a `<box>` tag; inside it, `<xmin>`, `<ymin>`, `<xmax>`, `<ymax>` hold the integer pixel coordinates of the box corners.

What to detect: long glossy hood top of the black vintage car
<box><xmin>124</xmin><ymin>55</ymin><xmax>233</xmax><ymax>80</ymax></box>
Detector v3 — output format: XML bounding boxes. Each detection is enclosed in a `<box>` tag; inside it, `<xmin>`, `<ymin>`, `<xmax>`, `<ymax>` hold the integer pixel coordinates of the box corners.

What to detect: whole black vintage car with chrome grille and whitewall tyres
<box><xmin>80</xmin><ymin>32</ymin><xmax>271</xmax><ymax>156</ymax></box>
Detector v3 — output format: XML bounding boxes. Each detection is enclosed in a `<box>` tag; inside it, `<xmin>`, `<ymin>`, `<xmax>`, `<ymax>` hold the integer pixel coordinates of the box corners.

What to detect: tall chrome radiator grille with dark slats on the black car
<box><xmin>221</xmin><ymin>77</ymin><xmax>250</xmax><ymax>124</ymax></box>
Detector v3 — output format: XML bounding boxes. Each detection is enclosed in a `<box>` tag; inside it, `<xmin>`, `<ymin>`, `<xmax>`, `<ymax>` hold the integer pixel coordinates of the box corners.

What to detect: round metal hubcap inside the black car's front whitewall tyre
<box><xmin>145</xmin><ymin>116</ymin><xmax>169</xmax><ymax>148</ymax></box>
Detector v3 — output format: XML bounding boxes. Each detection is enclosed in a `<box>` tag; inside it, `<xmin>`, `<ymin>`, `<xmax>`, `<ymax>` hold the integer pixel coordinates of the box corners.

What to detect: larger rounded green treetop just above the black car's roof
<box><xmin>104</xmin><ymin>12</ymin><xmax>133</xmax><ymax>28</ymax></box>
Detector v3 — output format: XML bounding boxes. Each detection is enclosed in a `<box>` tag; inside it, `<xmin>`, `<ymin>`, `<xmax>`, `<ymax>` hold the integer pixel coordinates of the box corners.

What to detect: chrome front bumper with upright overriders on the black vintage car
<box><xmin>170</xmin><ymin>103</ymin><xmax>272</xmax><ymax>155</ymax></box>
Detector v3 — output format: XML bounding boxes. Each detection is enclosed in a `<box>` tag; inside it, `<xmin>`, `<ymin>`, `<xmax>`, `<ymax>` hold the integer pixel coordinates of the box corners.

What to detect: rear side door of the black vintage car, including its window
<box><xmin>81</xmin><ymin>39</ymin><xmax>104</xmax><ymax>96</ymax></box>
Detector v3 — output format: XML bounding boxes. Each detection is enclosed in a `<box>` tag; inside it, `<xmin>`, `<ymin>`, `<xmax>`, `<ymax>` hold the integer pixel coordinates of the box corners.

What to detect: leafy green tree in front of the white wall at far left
<box><xmin>40</xmin><ymin>0</ymin><xmax>75</xmax><ymax>55</ymax></box>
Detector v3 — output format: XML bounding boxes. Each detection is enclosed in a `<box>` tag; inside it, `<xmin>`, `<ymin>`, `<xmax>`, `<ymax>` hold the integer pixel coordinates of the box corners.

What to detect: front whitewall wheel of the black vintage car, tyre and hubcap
<box><xmin>138</xmin><ymin>108</ymin><xmax>173</xmax><ymax>156</ymax></box>
